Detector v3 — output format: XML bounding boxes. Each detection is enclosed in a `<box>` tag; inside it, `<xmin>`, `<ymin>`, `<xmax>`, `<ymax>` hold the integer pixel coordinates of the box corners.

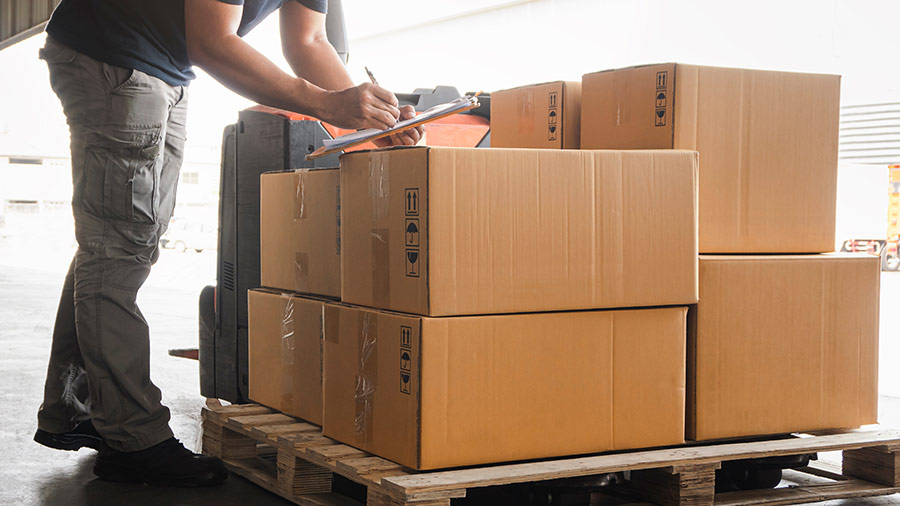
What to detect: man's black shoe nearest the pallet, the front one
<box><xmin>94</xmin><ymin>437</ymin><xmax>228</xmax><ymax>487</ymax></box>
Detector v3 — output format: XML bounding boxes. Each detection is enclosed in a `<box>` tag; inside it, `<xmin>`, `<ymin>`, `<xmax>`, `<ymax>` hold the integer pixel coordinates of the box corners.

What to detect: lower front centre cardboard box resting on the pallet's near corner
<box><xmin>323</xmin><ymin>306</ymin><xmax>687</xmax><ymax>469</ymax></box>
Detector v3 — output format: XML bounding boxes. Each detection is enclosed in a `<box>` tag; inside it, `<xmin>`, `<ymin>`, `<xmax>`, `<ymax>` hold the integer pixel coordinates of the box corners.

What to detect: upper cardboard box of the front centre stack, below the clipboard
<box><xmin>341</xmin><ymin>147</ymin><xmax>697</xmax><ymax>316</ymax></box>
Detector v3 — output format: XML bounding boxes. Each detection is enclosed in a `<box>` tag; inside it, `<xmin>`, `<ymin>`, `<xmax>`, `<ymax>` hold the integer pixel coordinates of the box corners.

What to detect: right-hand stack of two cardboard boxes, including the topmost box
<box><xmin>581</xmin><ymin>64</ymin><xmax>879</xmax><ymax>440</ymax></box>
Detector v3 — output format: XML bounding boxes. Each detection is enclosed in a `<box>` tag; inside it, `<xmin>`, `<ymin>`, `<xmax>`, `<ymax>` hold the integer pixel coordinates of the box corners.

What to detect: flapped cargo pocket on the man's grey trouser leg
<box><xmin>80</xmin><ymin>128</ymin><xmax>162</xmax><ymax>223</ymax></box>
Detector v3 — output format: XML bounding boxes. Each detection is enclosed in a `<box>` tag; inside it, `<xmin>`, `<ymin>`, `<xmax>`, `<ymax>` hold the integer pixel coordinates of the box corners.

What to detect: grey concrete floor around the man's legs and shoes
<box><xmin>0</xmin><ymin>218</ymin><xmax>900</xmax><ymax>506</ymax></box>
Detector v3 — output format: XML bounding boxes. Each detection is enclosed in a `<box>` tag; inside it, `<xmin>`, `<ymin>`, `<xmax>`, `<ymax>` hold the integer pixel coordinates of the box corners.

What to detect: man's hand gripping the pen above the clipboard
<box><xmin>319</xmin><ymin>83</ymin><xmax>400</xmax><ymax>130</ymax></box>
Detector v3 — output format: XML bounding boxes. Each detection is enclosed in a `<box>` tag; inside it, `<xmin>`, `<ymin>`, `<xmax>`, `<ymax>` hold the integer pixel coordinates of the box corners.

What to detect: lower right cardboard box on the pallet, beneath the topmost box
<box><xmin>687</xmin><ymin>254</ymin><xmax>881</xmax><ymax>440</ymax></box>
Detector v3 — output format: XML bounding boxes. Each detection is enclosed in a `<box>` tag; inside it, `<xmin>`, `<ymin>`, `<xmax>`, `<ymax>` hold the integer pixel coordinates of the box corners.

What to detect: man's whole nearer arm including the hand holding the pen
<box><xmin>184</xmin><ymin>0</ymin><xmax>400</xmax><ymax>128</ymax></box>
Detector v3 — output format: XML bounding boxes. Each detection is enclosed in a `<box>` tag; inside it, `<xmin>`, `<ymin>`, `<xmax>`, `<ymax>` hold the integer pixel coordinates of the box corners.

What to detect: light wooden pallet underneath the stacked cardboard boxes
<box><xmin>203</xmin><ymin>400</ymin><xmax>900</xmax><ymax>506</ymax></box>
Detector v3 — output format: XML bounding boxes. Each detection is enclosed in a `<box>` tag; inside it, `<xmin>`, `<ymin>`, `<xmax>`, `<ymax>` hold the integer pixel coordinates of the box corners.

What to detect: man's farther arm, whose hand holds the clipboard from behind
<box><xmin>280</xmin><ymin>0</ymin><xmax>424</xmax><ymax>145</ymax></box>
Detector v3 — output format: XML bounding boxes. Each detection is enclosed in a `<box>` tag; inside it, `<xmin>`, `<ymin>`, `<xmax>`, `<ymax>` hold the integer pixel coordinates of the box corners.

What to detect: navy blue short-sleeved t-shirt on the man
<box><xmin>47</xmin><ymin>0</ymin><xmax>328</xmax><ymax>86</ymax></box>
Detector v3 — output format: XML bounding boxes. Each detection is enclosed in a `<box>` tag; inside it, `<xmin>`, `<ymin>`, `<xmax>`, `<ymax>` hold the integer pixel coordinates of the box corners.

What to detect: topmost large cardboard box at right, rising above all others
<box><xmin>581</xmin><ymin>63</ymin><xmax>840</xmax><ymax>253</ymax></box>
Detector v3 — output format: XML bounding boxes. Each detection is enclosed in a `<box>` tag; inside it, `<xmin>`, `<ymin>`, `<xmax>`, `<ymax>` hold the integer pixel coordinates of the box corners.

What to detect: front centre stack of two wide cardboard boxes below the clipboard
<box><xmin>324</xmin><ymin>147</ymin><xmax>697</xmax><ymax>469</ymax></box>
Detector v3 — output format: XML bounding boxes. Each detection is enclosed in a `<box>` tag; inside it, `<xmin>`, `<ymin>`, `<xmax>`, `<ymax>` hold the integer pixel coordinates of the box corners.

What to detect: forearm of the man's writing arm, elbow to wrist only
<box><xmin>190</xmin><ymin>35</ymin><xmax>326</xmax><ymax>116</ymax></box>
